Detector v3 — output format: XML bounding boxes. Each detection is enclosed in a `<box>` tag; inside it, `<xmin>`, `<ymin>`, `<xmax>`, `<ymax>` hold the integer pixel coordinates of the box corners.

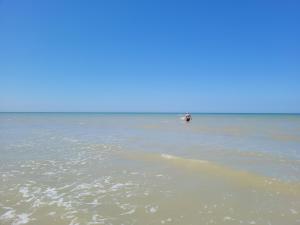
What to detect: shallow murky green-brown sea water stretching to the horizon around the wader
<box><xmin>0</xmin><ymin>113</ymin><xmax>300</xmax><ymax>225</ymax></box>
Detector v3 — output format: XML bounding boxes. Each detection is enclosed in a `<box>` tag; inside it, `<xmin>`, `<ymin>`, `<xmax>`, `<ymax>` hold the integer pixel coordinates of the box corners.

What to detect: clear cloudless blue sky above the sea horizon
<box><xmin>0</xmin><ymin>0</ymin><xmax>300</xmax><ymax>113</ymax></box>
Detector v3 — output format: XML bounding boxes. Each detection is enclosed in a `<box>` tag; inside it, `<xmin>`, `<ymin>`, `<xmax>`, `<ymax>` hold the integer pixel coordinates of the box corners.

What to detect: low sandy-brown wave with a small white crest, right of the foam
<box><xmin>118</xmin><ymin>152</ymin><xmax>300</xmax><ymax>197</ymax></box>
